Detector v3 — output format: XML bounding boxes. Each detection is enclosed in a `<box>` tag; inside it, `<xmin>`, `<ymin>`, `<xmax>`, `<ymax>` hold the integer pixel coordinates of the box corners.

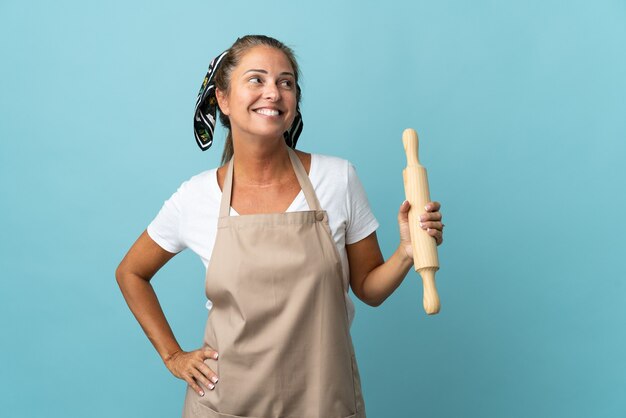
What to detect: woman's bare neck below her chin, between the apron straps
<box><xmin>233</xmin><ymin>135</ymin><xmax>293</xmax><ymax>186</ymax></box>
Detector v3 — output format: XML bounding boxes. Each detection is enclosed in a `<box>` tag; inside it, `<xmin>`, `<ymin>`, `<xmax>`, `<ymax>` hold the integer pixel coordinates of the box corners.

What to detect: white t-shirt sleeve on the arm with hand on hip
<box><xmin>147</xmin><ymin>183</ymin><xmax>187</xmax><ymax>253</ymax></box>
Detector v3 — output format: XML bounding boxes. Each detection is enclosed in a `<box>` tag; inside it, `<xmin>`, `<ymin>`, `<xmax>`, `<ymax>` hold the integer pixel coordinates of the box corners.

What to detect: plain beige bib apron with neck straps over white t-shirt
<box><xmin>183</xmin><ymin>149</ymin><xmax>365</xmax><ymax>418</ymax></box>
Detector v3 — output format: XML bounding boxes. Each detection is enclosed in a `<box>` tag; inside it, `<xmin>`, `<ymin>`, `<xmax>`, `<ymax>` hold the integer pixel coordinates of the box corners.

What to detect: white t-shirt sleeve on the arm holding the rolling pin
<box><xmin>346</xmin><ymin>163</ymin><xmax>379</xmax><ymax>244</ymax></box>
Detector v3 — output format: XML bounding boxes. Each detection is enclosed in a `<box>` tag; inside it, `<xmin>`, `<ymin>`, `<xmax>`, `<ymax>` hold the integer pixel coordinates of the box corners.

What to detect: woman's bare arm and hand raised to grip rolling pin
<box><xmin>346</xmin><ymin>202</ymin><xmax>443</xmax><ymax>306</ymax></box>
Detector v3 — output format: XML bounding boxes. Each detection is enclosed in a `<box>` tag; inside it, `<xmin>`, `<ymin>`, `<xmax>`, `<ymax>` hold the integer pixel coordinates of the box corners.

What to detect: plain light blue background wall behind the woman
<box><xmin>0</xmin><ymin>0</ymin><xmax>626</xmax><ymax>418</ymax></box>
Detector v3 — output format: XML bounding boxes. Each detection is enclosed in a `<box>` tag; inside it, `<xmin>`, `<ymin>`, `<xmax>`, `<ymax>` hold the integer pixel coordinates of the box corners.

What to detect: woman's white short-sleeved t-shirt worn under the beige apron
<box><xmin>147</xmin><ymin>154</ymin><xmax>378</xmax><ymax>324</ymax></box>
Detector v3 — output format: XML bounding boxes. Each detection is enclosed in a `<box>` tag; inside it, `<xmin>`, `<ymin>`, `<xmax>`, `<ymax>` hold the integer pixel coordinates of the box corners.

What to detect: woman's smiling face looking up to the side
<box><xmin>217</xmin><ymin>46</ymin><xmax>296</xmax><ymax>139</ymax></box>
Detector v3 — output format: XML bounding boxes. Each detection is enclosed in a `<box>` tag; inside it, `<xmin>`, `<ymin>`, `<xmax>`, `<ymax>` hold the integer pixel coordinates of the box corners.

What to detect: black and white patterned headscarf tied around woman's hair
<box><xmin>193</xmin><ymin>50</ymin><xmax>304</xmax><ymax>151</ymax></box>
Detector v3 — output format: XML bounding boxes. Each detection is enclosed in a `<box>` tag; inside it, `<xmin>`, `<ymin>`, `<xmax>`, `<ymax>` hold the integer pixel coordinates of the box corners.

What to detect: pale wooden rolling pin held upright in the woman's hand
<box><xmin>402</xmin><ymin>129</ymin><xmax>441</xmax><ymax>315</ymax></box>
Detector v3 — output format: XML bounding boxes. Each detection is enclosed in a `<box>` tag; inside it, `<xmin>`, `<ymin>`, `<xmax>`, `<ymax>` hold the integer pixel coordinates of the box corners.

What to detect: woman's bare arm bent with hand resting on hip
<box><xmin>115</xmin><ymin>231</ymin><xmax>218</xmax><ymax>396</ymax></box>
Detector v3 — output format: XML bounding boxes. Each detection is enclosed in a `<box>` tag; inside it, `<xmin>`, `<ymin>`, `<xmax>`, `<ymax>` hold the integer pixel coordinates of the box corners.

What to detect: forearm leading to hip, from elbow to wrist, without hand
<box><xmin>117</xmin><ymin>273</ymin><xmax>181</xmax><ymax>362</ymax></box>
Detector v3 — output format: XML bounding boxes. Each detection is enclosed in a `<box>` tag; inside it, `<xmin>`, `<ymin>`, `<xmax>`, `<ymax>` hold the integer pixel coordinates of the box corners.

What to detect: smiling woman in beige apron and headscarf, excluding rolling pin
<box><xmin>116</xmin><ymin>36</ymin><xmax>443</xmax><ymax>418</ymax></box>
